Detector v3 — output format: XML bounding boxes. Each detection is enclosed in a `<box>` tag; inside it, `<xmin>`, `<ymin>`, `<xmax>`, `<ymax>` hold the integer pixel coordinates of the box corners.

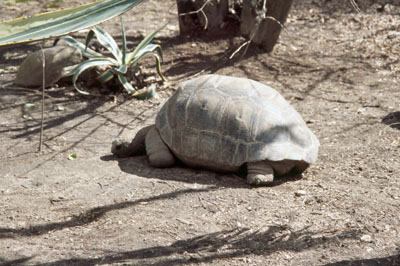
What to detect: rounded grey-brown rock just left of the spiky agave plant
<box><xmin>15</xmin><ymin>46</ymin><xmax>82</xmax><ymax>87</ymax></box>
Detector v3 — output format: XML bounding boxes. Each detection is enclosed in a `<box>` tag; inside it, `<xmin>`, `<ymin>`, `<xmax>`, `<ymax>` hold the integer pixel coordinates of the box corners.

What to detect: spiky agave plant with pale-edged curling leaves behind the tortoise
<box><xmin>61</xmin><ymin>20</ymin><xmax>167</xmax><ymax>97</ymax></box>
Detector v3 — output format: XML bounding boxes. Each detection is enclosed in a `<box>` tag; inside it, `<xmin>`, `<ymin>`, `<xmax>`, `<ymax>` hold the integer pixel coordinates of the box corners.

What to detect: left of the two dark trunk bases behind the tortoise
<box><xmin>176</xmin><ymin>0</ymin><xmax>229</xmax><ymax>34</ymax></box>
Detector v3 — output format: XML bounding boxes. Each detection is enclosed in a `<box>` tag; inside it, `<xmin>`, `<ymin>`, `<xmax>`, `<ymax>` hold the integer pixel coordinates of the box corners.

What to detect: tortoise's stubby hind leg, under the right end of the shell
<box><xmin>247</xmin><ymin>161</ymin><xmax>274</xmax><ymax>186</ymax></box>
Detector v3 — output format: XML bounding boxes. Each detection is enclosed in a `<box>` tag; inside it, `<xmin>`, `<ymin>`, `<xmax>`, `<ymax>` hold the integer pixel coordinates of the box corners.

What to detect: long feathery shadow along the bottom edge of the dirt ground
<box><xmin>1</xmin><ymin>226</ymin><xmax>360</xmax><ymax>266</ymax></box>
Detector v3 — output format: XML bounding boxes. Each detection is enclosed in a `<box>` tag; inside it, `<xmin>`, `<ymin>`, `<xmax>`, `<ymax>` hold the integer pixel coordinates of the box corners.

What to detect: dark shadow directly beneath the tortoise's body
<box><xmin>100</xmin><ymin>154</ymin><xmax>302</xmax><ymax>188</ymax></box>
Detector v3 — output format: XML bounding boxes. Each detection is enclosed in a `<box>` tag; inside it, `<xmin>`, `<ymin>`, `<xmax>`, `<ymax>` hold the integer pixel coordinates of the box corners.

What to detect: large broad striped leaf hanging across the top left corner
<box><xmin>0</xmin><ymin>0</ymin><xmax>143</xmax><ymax>46</ymax></box>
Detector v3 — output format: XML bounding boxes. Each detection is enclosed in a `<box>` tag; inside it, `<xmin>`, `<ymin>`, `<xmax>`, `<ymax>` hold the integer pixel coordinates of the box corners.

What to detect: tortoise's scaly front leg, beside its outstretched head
<box><xmin>145</xmin><ymin>127</ymin><xmax>175</xmax><ymax>168</ymax></box>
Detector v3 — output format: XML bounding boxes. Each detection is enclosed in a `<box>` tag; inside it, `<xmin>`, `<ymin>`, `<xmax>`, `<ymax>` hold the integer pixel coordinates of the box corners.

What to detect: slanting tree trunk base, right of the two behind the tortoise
<box><xmin>240</xmin><ymin>0</ymin><xmax>293</xmax><ymax>53</ymax></box>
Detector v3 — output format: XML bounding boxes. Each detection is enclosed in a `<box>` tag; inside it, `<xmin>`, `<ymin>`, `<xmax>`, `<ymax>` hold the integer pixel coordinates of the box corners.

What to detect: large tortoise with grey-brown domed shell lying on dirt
<box><xmin>111</xmin><ymin>74</ymin><xmax>319</xmax><ymax>185</ymax></box>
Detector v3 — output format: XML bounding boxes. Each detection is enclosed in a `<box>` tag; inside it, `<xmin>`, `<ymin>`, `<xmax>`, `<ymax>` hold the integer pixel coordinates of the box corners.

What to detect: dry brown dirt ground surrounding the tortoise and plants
<box><xmin>0</xmin><ymin>0</ymin><xmax>400</xmax><ymax>266</ymax></box>
